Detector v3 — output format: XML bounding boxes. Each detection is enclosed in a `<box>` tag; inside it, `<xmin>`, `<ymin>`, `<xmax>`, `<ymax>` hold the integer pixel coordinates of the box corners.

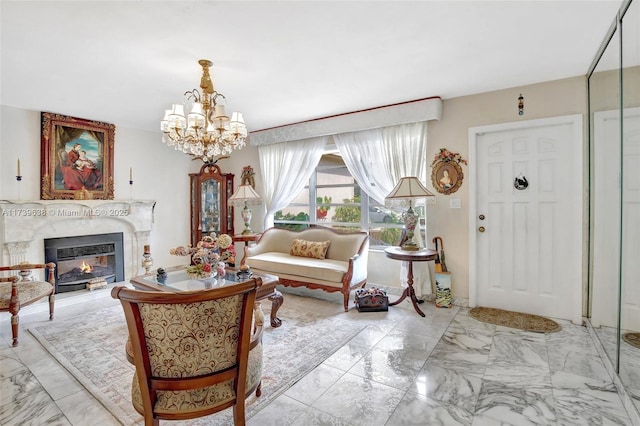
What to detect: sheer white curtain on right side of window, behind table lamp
<box><xmin>333</xmin><ymin>122</ymin><xmax>431</xmax><ymax>294</ymax></box>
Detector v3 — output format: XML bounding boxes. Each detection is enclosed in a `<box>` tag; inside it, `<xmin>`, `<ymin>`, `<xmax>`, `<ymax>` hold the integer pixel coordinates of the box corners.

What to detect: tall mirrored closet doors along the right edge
<box><xmin>588</xmin><ymin>0</ymin><xmax>640</xmax><ymax>411</ymax></box>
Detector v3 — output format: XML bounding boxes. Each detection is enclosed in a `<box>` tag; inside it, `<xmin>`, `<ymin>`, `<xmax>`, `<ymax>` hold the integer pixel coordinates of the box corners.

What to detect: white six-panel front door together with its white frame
<box><xmin>469</xmin><ymin>116</ymin><xmax>584</xmax><ymax>323</ymax></box>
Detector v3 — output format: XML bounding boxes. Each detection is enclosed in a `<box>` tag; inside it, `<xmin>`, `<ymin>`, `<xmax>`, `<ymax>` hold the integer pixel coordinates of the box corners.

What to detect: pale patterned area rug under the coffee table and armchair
<box><xmin>29</xmin><ymin>295</ymin><xmax>364</xmax><ymax>426</ymax></box>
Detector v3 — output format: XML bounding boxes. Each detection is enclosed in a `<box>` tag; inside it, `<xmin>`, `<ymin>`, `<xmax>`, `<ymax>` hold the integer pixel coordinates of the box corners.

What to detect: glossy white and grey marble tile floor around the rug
<box><xmin>0</xmin><ymin>282</ymin><xmax>633</xmax><ymax>426</ymax></box>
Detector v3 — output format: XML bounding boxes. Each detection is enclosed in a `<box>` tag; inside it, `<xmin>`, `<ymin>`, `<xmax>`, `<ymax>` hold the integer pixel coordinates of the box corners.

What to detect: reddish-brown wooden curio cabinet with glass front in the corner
<box><xmin>189</xmin><ymin>164</ymin><xmax>234</xmax><ymax>246</ymax></box>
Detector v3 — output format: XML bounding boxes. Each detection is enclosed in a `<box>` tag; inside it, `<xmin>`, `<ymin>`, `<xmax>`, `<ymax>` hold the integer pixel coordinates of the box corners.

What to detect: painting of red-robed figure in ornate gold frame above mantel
<box><xmin>40</xmin><ymin>112</ymin><xmax>115</xmax><ymax>200</ymax></box>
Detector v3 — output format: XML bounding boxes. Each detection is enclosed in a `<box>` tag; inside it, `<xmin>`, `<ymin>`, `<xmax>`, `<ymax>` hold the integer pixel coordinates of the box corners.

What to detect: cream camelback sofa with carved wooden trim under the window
<box><xmin>242</xmin><ymin>226</ymin><xmax>369</xmax><ymax>311</ymax></box>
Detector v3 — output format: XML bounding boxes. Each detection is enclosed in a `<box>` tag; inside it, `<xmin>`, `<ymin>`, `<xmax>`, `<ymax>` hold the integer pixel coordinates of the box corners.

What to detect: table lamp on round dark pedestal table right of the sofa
<box><xmin>385</xmin><ymin>176</ymin><xmax>434</xmax><ymax>251</ymax></box>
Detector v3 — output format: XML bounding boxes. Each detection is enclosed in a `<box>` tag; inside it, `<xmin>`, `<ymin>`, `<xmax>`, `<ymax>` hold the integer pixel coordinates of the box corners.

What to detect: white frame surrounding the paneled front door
<box><xmin>469</xmin><ymin>114</ymin><xmax>585</xmax><ymax>324</ymax></box>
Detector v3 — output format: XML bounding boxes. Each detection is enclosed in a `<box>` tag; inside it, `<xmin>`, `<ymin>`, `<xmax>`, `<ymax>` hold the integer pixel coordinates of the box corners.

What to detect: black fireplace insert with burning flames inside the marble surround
<box><xmin>44</xmin><ymin>232</ymin><xmax>124</xmax><ymax>293</ymax></box>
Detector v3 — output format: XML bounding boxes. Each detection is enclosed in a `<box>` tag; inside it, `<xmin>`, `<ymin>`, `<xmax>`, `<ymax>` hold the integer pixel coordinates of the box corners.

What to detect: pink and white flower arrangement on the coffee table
<box><xmin>169</xmin><ymin>232</ymin><xmax>235</xmax><ymax>278</ymax></box>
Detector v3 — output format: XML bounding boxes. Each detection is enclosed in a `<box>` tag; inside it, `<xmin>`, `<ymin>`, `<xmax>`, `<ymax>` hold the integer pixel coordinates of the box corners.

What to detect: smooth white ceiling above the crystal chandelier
<box><xmin>0</xmin><ymin>0</ymin><xmax>622</xmax><ymax>131</ymax></box>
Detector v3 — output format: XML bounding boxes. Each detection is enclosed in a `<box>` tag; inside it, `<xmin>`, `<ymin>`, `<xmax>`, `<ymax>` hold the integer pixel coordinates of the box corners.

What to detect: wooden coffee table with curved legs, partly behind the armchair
<box><xmin>129</xmin><ymin>266</ymin><xmax>284</xmax><ymax>327</ymax></box>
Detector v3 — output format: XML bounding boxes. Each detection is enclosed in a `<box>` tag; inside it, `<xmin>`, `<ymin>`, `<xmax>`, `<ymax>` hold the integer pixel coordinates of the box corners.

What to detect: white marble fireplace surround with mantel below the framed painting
<box><xmin>0</xmin><ymin>200</ymin><xmax>156</xmax><ymax>280</ymax></box>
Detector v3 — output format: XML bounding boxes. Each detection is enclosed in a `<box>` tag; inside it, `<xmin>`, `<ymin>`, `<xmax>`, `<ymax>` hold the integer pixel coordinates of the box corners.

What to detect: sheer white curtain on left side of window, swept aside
<box><xmin>258</xmin><ymin>136</ymin><xmax>328</xmax><ymax>229</ymax></box>
